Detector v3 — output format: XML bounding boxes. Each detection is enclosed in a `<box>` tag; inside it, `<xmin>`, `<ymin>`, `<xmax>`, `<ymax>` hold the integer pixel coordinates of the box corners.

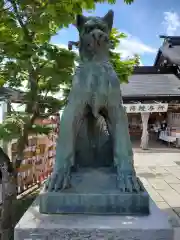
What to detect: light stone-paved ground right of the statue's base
<box><xmin>134</xmin><ymin>149</ymin><xmax>180</xmax><ymax>240</ymax></box>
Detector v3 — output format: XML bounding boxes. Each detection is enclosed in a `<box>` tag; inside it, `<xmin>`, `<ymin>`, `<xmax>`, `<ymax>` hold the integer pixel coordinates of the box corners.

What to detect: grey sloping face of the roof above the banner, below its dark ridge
<box><xmin>121</xmin><ymin>73</ymin><xmax>180</xmax><ymax>99</ymax></box>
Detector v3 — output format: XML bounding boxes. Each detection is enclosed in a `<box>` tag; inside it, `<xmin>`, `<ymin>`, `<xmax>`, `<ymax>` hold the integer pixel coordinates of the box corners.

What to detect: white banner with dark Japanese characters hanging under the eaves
<box><xmin>123</xmin><ymin>103</ymin><xmax>168</xmax><ymax>113</ymax></box>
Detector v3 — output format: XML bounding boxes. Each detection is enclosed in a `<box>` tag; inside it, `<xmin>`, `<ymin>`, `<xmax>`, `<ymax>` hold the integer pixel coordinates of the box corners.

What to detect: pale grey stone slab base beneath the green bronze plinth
<box><xmin>14</xmin><ymin>198</ymin><xmax>173</xmax><ymax>240</ymax></box>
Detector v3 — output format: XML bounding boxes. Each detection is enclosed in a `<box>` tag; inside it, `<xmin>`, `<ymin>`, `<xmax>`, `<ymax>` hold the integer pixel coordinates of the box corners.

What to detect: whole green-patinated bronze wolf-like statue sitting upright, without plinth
<box><xmin>47</xmin><ymin>11</ymin><xmax>140</xmax><ymax>195</ymax></box>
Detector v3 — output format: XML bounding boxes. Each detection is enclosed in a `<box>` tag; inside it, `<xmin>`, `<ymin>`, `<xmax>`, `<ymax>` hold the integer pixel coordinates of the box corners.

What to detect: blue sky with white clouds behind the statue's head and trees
<box><xmin>52</xmin><ymin>0</ymin><xmax>180</xmax><ymax>65</ymax></box>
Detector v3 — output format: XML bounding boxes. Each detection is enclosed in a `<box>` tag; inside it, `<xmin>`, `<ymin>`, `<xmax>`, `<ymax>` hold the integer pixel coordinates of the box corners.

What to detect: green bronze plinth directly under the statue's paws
<box><xmin>40</xmin><ymin>168</ymin><xmax>149</xmax><ymax>216</ymax></box>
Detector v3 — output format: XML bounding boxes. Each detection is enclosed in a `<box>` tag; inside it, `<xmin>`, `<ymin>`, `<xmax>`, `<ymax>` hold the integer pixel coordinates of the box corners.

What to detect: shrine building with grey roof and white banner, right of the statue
<box><xmin>121</xmin><ymin>36</ymin><xmax>180</xmax><ymax>149</ymax></box>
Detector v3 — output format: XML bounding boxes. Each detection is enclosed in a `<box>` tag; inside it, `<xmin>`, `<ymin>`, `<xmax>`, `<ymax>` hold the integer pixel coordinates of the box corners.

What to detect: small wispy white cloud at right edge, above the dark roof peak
<box><xmin>163</xmin><ymin>12</ymin><xmax>180</xmax><ymax>36</ymax></box>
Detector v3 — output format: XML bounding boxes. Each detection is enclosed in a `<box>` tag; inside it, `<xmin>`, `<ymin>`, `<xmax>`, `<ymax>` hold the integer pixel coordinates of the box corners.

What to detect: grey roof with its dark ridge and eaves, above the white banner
<box><xmin>121</xmin><ymin>66</ymin><xmax>180</xmax><ymax>100</ymax></box>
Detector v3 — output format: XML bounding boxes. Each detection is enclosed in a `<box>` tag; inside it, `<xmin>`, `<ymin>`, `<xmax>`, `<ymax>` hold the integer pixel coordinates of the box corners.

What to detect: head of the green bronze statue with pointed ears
<box><xmin>75</xmin><ymin>10</ymin><xmax>114</xmax><ymax>60</ymax></box>
